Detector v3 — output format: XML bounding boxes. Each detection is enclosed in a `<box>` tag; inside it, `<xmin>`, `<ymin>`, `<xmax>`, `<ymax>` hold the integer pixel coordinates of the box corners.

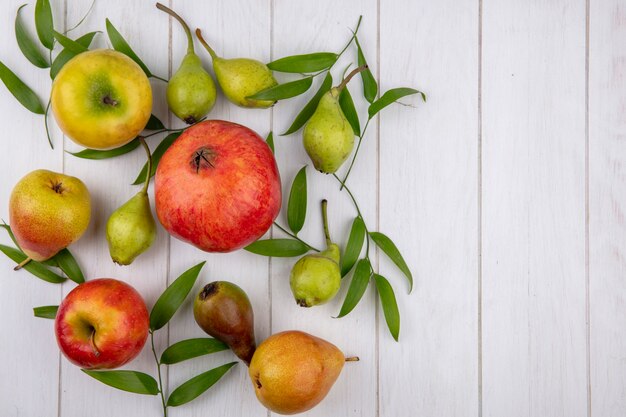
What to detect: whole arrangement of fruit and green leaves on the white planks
<box><xmin>0</xmin><ymin>0</ymin><xmax>426</xmax><ymax>416</ymax></box>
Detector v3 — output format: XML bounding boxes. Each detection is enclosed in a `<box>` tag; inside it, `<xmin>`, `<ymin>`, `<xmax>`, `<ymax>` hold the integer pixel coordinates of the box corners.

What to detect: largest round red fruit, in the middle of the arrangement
<box><xmin>154</xmin><ymin>120</ymin><xmax>282</xmax><ymax>252</ymax></box>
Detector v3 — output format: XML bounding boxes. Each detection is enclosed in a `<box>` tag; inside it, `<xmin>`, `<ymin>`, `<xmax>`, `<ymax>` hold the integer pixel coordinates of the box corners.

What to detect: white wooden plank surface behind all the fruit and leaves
<box><xmin>0</xmin><ymin>0</ymin><xmax>626</xmax><ymax>417</ymax></box>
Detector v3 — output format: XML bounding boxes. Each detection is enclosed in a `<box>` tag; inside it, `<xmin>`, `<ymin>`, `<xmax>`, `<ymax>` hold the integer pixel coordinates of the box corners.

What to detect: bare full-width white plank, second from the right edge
<box><xmin>482</xmin><ymin>1</ymin><xmax>587</xmax><ymax>416</ymax></box>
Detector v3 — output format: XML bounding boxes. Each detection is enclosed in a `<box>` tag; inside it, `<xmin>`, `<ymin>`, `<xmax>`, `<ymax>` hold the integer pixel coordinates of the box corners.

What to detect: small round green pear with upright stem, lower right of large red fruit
<box><xmin>289</xmin><ymin>200</ymin><xmax>341</xmax><ymax>307</ymax></box>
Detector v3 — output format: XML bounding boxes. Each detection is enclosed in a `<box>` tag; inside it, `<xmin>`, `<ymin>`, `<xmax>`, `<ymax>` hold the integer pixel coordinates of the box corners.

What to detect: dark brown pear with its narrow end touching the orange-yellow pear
<box><xmin>193</xmin><ymin>281</ymin><xmax>256</xmax><ymax>365</ymax></box>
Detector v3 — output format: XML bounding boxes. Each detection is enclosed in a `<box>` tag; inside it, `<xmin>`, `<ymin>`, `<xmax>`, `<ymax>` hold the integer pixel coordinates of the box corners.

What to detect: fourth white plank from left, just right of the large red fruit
<box><xmin>271</xmin><ymin>0</ymin><xmax>377</xmax><ymax>416</ymax></box>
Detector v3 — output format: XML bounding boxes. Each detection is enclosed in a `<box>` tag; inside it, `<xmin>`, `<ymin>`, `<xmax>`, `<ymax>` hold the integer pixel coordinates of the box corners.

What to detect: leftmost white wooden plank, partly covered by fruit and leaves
<box><xmin>0</xmin><ymin>1</ymin><xmax>64</xmax><ymax>417</ymax></box>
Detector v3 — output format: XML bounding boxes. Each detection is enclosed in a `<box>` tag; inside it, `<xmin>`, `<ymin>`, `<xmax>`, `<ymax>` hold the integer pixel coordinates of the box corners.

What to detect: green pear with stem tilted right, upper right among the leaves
<box><xmin>302</xmin><ymin>66</ymin><xmax>367</xmax><ymax>174</ymax></box>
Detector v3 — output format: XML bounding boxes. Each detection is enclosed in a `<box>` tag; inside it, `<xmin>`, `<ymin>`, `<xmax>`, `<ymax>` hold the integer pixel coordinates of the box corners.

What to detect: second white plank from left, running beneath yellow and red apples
<box><xmin>60</xmin><ymin>0</ymin><xmax>168</xmax><ymax>416</ymax></box>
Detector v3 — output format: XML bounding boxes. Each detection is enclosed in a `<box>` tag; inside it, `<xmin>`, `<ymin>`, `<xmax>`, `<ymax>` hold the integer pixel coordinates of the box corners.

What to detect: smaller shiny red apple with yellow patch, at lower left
<box><xmin>54</xmin><ymin>278</ymin><xmax>150</xmax><ymax>369</ymax></box>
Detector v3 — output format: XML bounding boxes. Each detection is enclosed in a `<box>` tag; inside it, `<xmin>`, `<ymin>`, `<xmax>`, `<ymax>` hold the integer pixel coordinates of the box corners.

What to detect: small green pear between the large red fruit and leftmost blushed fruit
<box><xmin>106</xmin><ymin>139</ymin><xmax>156</xmax><ymax>265</ymax></box>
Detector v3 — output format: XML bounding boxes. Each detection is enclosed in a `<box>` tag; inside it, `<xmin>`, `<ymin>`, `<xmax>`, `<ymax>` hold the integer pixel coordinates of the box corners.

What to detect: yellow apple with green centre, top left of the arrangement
<box><xmin>50</xmin><ymin>49</ymin><xmax>152</xmax><ymax>150</ymax></box>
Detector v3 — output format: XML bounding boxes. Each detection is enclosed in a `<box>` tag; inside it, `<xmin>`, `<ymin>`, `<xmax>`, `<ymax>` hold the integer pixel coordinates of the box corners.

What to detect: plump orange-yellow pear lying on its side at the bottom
<box><xmin>248</xmin><ymin>330</ymin><xmax>358</xmax><ymax>414</ymax></box>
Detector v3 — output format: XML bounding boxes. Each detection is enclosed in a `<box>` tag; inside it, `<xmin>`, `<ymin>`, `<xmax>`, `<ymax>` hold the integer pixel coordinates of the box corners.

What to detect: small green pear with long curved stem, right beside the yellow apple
<box><xmin>157</xmin><ymin>3</ymin><xmax>217</xmax><ymax>124</ymax></box>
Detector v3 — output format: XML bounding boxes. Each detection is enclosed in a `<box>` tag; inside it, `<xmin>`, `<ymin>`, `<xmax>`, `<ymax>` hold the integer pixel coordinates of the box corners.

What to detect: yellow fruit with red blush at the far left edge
<box><xmin>9</xmin><ymin>169</ymin><xmax>91</xmax><ymax>266</ymax></box>
